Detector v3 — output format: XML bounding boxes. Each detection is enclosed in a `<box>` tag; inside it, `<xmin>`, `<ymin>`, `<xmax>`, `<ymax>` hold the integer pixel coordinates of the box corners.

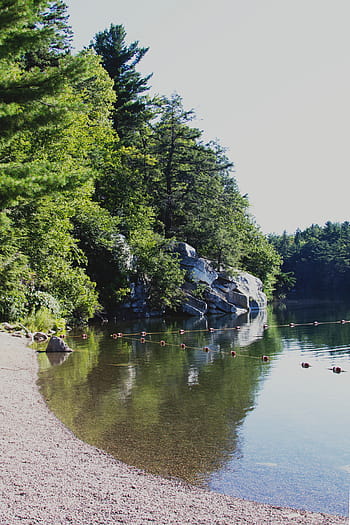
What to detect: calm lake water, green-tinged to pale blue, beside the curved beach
<box><xmin>39</xmin><ymin>305</ymin><xmax>350</xmax><ymax>515</ymax></box>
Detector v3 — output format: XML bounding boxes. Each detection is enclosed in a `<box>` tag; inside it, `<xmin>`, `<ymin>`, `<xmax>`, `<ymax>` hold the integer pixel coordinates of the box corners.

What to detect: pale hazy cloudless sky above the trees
<box><xmin>67</xmin><ymin>0</ymin><xmax>350</xmax><ymax>233</ymax></box>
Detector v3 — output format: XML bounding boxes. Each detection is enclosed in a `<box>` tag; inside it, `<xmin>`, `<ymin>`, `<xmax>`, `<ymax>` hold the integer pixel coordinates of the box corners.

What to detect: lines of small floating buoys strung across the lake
<box><xmin>60</xmin><ymin>319</ymin><xmax>350</xmax><ymax>374</ymax></box>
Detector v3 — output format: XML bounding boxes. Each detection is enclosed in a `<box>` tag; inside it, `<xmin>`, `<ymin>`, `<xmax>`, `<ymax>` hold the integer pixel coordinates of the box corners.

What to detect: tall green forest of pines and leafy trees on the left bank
<box><xmin>0</xmin><ymin>0</ymin><xmax>282</xmax><ymax>323</ymax></box>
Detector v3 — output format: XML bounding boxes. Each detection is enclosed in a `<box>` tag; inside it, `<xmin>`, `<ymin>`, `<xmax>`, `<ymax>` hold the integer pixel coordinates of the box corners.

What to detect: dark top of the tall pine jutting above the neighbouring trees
<box><xmin>90</xmin><ymin>24</ymin><xmax>152</xmax><ymax>143</ymax></box>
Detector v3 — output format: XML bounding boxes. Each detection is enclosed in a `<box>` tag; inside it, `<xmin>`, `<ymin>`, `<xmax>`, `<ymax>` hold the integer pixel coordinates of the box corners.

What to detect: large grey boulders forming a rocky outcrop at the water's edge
<box><xmin>174</xmin><ymin>242</ymin><xmax>267</xmax><ymax>316</ymax></box>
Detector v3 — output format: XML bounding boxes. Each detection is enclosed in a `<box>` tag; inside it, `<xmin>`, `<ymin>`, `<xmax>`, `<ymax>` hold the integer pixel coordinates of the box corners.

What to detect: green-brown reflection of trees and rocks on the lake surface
<box><xmin>40</xmin><ymin>313</ymin><xmax>278</xmax><ymax>483</ymax></box>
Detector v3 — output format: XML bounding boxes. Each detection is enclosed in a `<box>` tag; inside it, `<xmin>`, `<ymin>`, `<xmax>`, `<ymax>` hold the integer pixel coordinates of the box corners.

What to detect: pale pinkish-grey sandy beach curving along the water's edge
<box><xmin>0</xmin><ymin>333</ymin><xmax>348</xmax><ymax>525</ymax></box>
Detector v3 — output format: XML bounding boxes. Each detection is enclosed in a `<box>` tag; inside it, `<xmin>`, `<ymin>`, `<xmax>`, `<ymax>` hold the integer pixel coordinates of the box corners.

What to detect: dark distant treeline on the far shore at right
<box><xmin>269</xmin><ymin>221</ymin><xmax>350</xmax><ymax>299</ymax></box>
